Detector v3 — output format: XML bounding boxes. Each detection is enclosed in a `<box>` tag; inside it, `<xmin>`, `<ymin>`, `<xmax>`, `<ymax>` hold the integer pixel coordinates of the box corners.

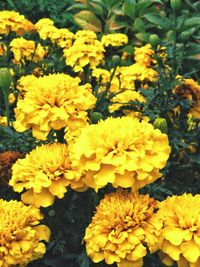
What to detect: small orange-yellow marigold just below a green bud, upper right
<box><xmin>134</xmin><ymin>44</ymin><xmax>155</xmax><ymax>67</ymax></box>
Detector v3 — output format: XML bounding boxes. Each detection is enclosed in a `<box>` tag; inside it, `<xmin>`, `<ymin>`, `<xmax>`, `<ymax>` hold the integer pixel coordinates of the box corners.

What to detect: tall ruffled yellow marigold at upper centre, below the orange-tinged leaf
<box><xmin>63</xmin><ymin>31</ymin><xmax>105</xmax><ymax>72</ymax></box>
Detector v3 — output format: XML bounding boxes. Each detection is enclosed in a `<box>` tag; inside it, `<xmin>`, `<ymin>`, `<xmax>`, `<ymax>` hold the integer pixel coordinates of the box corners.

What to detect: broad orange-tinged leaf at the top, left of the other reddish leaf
<box><xmin>73</xmin><ymin>10</ymin><xmax>102</xmax><ymax>32</ymax></box>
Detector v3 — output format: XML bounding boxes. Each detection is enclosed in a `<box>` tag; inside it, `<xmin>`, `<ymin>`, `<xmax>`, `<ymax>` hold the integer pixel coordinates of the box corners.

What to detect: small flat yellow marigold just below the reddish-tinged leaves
<box><xmin>101</xmin><ymin>33</ymin><xmax>128</xmax><ymax>46</ymax></box>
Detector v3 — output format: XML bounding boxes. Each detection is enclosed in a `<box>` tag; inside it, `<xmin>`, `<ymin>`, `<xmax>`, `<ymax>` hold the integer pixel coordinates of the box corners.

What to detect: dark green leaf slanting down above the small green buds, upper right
<box><xmin>144</xmin><ymin>13</ymin><xmax>170</xmax><ymax>30</ymax></box>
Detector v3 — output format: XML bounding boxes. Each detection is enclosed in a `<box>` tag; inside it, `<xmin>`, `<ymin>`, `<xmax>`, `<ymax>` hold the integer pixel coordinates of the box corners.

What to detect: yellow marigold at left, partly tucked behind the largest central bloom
<box><xmin>9</xmin><ymin>143</ymin><xmax>84</xmax><ymax>207</ymax></box>
